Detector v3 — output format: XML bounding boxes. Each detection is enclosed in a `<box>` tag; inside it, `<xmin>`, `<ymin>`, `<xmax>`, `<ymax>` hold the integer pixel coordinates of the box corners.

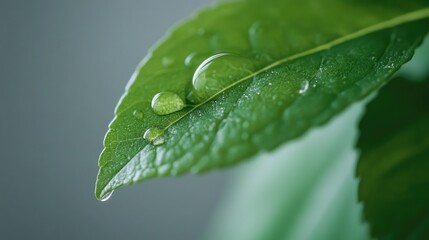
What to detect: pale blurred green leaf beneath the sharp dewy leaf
<box><xmin>204</xmin><ymin>99</ymin><xmax>369</xmax><ymax>240</ymax></box>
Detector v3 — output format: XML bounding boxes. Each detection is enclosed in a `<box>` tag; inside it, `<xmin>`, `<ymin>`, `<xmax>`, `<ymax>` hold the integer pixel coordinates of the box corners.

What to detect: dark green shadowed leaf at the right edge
<box><xmin>357</xmin><ymin>79</ymin><xmax>429</xmax><ymax>239</ymax></box>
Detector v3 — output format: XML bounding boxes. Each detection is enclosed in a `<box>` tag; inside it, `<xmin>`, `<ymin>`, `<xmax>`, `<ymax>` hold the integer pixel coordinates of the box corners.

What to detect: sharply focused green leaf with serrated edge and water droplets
<box><xmin>96</xmin><ymin>0</ymin><xmax>429</xmax><ymax>199</ymax></box>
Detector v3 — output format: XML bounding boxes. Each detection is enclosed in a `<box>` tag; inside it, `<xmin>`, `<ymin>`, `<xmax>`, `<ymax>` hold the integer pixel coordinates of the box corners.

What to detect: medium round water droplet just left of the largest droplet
<box><xmin>152</xmin><ymin>92</ymin><xmax>185</xmax><ymax>115</ymax></box>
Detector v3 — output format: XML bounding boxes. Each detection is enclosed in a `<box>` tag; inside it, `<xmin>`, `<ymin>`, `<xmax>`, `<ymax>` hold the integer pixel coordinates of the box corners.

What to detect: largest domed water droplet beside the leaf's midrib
<box><xmin>189</xmin><ymin>53</ymin><xmax>254</xmax><ymax>102</ymax></box>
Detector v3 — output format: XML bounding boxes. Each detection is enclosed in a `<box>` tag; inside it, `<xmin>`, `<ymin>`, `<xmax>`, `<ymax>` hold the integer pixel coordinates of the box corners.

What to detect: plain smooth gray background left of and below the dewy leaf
<box><xmin>0</xmin><ymin>0</ymin><xmax>230</xmax><ymax>239</ymax></box>
